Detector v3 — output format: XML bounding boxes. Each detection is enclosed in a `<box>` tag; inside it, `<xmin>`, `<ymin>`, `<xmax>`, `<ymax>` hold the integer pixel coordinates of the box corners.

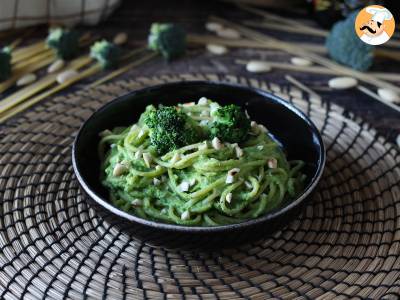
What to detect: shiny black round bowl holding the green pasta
<box><xmin>72</xmin><ymin>82</ymin><xmax>325</xmax><ymax>248</ymax></box>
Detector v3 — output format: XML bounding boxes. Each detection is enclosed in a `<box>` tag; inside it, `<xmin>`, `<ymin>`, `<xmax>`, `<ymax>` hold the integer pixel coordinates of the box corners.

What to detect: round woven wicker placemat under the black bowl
<box><xmin>0</xmin><ymin>75</ymin><xmax>400</xmax><ymax>300</ymax></box>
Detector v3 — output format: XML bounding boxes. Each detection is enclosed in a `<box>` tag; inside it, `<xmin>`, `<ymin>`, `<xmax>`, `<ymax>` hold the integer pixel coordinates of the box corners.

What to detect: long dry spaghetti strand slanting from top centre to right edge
<box><xmin>211</xmin><ymin>17</ymin><xmax>400</xmax><ymax>93</ymax></box>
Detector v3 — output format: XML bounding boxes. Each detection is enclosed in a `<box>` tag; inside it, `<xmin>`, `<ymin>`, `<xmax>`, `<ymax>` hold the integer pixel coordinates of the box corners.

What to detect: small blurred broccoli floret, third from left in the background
<box><xmin>90</xmin><ymin>40</ymin><xmax>121</xmax><ymax>69</ymax></box>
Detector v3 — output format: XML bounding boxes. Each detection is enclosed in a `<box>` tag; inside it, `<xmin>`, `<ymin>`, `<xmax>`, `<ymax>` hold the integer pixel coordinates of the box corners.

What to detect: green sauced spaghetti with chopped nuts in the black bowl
<box><xmin>99</xmin><ymin>100</ymin><xmax>305</xmax><ymax>226</ymax></box>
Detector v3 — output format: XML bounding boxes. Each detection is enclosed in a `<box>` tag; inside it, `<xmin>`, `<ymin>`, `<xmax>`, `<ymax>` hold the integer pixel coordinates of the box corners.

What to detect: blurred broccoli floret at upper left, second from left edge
<box><xmin>46</xmin><ymin>28</ymin><xmax>79</xmax><ymax>59</ymax></box>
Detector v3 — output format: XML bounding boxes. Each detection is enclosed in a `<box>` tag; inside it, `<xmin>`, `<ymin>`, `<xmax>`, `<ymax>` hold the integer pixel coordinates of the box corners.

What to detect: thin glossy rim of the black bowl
<box><xmin>72</xmin><ymin>80</ymin><xmax>326</xmax><ymax>233</ymax></box>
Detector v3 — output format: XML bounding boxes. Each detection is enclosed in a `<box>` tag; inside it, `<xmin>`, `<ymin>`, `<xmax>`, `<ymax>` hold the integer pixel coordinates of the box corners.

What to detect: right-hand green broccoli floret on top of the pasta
<box><xmin>210</xmin><ymin>104</ymin><xmax>250</xmax><ymax>143</ymax></box>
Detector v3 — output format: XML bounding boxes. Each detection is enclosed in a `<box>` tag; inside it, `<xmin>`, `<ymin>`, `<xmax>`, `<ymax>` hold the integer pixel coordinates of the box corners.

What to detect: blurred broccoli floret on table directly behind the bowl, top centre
<box><xmin>148</xmin><ymin>23</ymin><xmax>186</xmax><ymax>60</ymax></box>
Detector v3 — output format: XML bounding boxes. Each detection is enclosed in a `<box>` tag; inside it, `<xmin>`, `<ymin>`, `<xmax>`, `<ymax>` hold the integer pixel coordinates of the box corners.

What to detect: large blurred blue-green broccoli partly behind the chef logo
<box><xmin>325</xmin><ymin>11</ymin><xmax>374</xmax><ymax>71</ymax></box>
